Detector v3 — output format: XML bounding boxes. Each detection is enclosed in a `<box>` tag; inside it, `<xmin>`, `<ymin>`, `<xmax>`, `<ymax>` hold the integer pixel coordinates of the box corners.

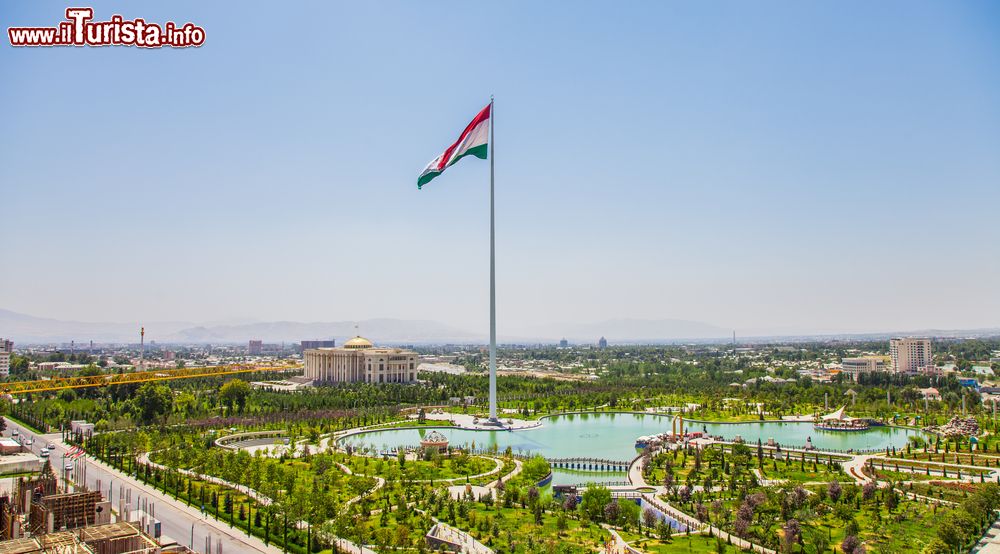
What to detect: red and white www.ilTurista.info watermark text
<box><xmin>7</xmin><ymin>8</ymin><xmax>205</xmax><ymax>48</ymax></box>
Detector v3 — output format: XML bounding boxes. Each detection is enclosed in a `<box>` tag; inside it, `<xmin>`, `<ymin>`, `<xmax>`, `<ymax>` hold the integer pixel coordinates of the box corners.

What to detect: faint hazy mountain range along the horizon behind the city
<box><xmin>0</xmin><ymin>309</ymin><xmax>1000</xmax><ymax>345</ymax></box>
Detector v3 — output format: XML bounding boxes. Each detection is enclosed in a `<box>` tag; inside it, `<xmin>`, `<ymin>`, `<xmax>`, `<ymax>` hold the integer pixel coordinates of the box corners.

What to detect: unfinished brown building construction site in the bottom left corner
<box><xmin>0</xmin><ymin>463</ymin><xmax>179</xmax><ymax>554</ymax></box>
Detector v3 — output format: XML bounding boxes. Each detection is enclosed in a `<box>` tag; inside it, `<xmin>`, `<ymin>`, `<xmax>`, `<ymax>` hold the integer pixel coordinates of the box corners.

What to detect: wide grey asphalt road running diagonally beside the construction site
<box><xmin>3</xmin><ymin>418</ymin><xmax>281</xmax><ymax>554</ymax></box>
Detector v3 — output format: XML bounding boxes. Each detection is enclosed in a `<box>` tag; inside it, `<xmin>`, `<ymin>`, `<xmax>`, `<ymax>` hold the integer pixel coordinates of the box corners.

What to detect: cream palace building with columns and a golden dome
<box><xmin>303</xmin><ymin>337</ymin><xmax>417</xmax><ymax>385</ymax></box>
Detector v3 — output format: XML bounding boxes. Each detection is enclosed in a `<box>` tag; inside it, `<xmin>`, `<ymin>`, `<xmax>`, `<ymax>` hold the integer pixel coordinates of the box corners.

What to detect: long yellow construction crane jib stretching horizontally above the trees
<box><xmin>0</xmin><ymin>364</ymin><xmax>302</xmax><ymax>395</ymax></box>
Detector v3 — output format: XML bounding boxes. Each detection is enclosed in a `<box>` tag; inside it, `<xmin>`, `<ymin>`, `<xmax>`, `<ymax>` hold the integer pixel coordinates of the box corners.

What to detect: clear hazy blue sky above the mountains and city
<box><xmin>0</xmin><ymin>1</ymin><xmax>1000</xmax><ymax>334</ymax></box>
